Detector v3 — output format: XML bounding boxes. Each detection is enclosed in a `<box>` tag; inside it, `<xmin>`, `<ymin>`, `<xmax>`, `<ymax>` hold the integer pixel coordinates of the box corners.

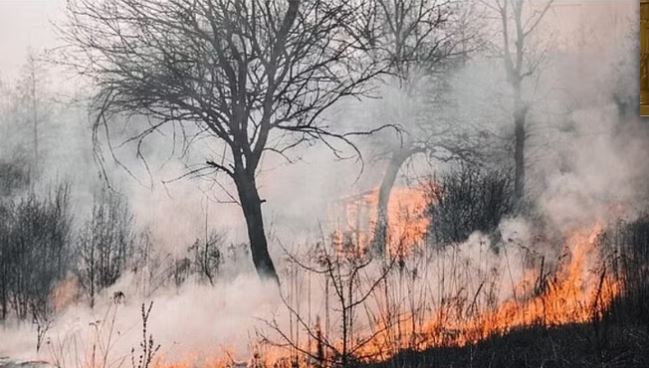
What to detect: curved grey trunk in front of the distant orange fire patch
<box><xmin>372</xmin><ymin>148</ymin><xmax>413</xmax><ymax>255</ymax></box>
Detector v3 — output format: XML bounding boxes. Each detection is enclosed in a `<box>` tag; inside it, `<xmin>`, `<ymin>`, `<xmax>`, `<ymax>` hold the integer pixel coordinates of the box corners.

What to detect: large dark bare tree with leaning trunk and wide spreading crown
<box><xmin>63</xmin><ymin>0</ymin><xmax>379</xmax><ymax>279</ymax></box>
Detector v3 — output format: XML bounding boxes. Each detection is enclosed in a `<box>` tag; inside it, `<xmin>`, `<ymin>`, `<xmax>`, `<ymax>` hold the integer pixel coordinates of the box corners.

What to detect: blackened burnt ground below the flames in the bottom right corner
<box><xmin>366</xmin><ymin>323</ymin><xmax>649</xmax><ymax>368</ymax></box>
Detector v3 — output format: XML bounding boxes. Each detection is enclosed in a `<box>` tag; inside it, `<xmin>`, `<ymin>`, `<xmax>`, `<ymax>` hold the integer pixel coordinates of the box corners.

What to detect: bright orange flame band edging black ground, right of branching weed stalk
<box><xmin>362</xmin><ymin>225</ymin><xmax>622</xmax><ymax>358</ymax></box>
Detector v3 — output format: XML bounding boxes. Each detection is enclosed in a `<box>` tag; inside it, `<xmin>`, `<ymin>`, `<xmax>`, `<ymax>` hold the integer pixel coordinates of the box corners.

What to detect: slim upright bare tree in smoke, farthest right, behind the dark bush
<box><xmin>483</xmin><ymin>0</ymin><xmax>554</xmax><ymax>203</ymax></box>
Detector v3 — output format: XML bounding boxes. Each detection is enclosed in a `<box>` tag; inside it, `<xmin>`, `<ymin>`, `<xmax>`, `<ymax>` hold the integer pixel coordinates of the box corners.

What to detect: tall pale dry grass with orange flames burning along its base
<box><xmin>144</xmin><ymin>221</ymin><xmax>623</xmax><ymax>368</ymax></box>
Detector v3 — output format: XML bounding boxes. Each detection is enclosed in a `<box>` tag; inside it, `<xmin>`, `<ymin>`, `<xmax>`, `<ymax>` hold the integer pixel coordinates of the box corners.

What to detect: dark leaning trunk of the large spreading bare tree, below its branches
<box><xmin>235</xmin><ymin>172</ymin><xmax>279</xmax><ymax>283</ymax></box>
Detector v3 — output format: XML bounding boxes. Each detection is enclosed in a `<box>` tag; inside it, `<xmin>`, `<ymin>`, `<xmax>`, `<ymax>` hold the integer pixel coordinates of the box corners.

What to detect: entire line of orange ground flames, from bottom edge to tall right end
<box><xmin>144</xmin><ymin>221</ymin><xmax>622</xmax><ymax>368</ymax></box>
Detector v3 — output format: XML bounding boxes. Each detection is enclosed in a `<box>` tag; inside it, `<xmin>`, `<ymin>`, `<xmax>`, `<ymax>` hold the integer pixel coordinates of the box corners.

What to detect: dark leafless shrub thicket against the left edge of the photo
<box><xmin>0</xmin><ymin>185</ymin><xmax>71</xmax><ymax>325</ymax></box>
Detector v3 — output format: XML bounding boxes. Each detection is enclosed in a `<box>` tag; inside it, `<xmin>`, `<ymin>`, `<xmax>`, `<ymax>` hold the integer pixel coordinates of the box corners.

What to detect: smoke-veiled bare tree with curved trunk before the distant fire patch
<box><xmin>350</xmin><ymin>0</ymin><xmax>477</xmax><ymax>254</ymax></box>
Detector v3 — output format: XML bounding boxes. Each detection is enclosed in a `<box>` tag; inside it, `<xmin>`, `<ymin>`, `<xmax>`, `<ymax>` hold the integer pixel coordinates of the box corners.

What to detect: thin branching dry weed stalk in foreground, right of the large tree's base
<box><xmin>262</xmin><ymin>242</ymin><xmax>395</xmax><ymax>367</ymax></box>
